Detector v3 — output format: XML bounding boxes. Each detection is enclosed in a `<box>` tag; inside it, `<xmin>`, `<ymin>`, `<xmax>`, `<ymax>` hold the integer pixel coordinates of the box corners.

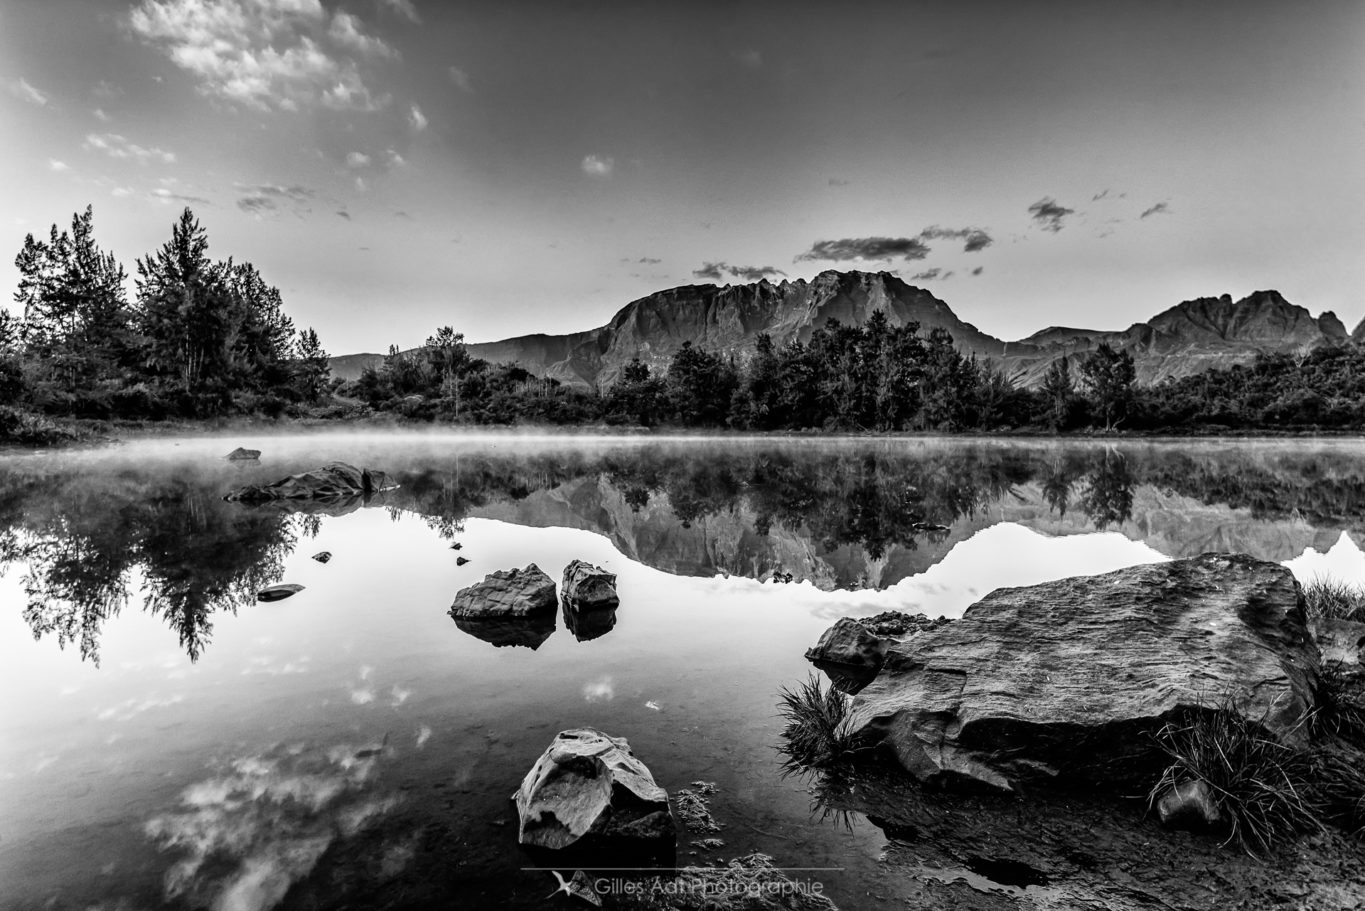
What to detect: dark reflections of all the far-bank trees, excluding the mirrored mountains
<box><xmin>8</xmin><ymin>441</ymin><xmax>1365</xmax><ymax>660</ymax></box>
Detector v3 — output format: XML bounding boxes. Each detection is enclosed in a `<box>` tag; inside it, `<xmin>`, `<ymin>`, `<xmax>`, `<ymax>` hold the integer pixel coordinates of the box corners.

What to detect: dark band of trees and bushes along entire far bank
<box><xmin>8</xmin><ymin>208</ymin><xmax>1365</xmax><ymax>445</ymax></box>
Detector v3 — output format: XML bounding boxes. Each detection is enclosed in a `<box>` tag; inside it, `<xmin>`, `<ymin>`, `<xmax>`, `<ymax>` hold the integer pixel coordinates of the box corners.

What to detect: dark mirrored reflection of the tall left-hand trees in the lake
<box><xmin>0</xmin><ymin>473</ymin><xmax>298</xmax><ymax>662</ymax></box>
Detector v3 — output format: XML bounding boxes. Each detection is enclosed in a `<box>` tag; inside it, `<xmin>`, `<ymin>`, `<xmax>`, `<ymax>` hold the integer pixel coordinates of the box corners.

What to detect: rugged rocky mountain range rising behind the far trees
<box><xmin>332</xmin><ymin>270</ymin><xmax>1343</xmax><ymax>388</ymax></box>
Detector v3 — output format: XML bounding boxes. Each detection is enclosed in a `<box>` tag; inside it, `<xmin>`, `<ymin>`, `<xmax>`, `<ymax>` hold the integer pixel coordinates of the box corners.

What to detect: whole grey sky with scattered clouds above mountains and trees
<box><xmin>0</xmin><ymin>0</ymin><xmax>1365</xmax><ymax>354</ymax></box>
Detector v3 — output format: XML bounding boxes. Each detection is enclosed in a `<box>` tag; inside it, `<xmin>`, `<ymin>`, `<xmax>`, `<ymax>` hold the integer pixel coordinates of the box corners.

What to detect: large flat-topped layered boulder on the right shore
<box><xmin>850</xmin><ymin>553</ymin><xmax>1317</xmax><ymax>789</ymax></box>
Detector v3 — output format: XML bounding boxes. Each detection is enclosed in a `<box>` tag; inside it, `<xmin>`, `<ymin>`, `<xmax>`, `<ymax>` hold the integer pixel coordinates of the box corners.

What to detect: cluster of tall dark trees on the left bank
<box><xmin>0</xmin><ymin>206</ymin><xmax>330</xmax><ymax>419</ymax></box>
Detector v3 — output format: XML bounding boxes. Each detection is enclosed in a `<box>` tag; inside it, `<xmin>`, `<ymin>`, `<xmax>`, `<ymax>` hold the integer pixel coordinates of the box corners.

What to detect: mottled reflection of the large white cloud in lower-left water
<box><xmin>143</xmin><ymin>744</ymin><xmax>397</xmax><ymax>911</ymax></box>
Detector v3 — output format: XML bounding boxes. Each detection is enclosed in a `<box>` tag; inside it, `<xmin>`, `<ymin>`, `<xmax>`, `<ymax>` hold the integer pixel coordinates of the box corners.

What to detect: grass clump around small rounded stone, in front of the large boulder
<box><xmin>1148</xmin><ymin>706</ymin><xmax>1325</xmax><ymax>855</ymax></box>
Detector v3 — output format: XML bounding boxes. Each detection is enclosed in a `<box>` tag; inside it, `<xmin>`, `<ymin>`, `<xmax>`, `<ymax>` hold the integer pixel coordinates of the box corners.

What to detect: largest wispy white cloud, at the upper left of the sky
<box><xmin>127</xmin><ymin>0</ymin><xmax>393</xmax><ymax>111</ymax></box>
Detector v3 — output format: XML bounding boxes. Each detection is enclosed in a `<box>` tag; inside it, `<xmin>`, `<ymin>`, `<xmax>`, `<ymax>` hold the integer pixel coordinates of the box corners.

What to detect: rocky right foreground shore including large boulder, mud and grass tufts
<box><xmin>779</xmin><ymin>553</ymin><xmax>1365</xmax><ymax>910</ymax></box>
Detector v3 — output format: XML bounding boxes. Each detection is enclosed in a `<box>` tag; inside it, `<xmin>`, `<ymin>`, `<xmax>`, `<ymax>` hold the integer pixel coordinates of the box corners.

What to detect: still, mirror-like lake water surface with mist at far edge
<box><xmin>0</xmin><ymin>434</ymin><xmax>1365</xmax><ymax>910</ymax></box>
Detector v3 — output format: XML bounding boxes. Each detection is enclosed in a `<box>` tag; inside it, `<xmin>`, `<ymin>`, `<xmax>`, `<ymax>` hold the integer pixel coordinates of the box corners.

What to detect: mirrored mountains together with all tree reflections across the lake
<box><xmin>8</xmin><ymin>440</ymin><xmax>1365</xmax><ymax>660</ymax></box>
